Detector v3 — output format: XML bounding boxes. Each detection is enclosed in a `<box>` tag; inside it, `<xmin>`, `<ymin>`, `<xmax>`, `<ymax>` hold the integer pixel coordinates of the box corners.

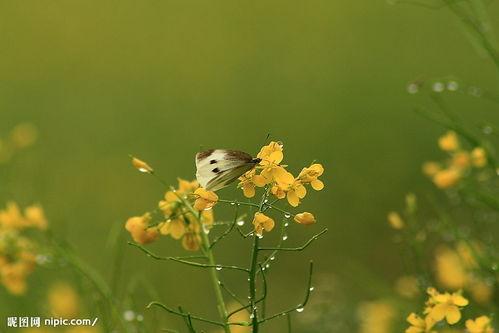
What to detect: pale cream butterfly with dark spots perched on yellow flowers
<box><xmin>196</xmin><ymin>149</ymin><xmax>261</xmax><ymax>191</ymax></box>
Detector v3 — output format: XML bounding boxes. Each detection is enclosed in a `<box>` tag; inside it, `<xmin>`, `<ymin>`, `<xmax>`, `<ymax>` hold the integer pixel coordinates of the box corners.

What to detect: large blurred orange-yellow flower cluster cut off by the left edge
<box><xmin>0</xmin><ymin>202</ymin><xmax>47</xmax><ymax>295</ymax></box>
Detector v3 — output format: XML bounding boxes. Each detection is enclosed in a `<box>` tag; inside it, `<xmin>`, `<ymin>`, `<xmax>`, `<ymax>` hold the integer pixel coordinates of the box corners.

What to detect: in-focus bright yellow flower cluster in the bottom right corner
<box><xmin>405</xmin><ymin>288</ymin><xmax>493</xmax><ymax>333</ymax></box>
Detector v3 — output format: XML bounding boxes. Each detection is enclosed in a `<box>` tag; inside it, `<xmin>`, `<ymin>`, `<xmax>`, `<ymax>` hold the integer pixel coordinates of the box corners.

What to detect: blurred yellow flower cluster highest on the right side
<box><xmin>423</xmin><ymin>131</ymin><xmax>487</xmax><ymax>189</ymax></box>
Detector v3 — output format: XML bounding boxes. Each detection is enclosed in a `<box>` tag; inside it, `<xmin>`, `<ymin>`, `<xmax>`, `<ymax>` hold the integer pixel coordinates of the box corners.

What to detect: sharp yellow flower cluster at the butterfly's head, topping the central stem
<box><xmin>239</xmin><ymin>142</ymin><xmax>324</xmax><ymax>207</ymax></box>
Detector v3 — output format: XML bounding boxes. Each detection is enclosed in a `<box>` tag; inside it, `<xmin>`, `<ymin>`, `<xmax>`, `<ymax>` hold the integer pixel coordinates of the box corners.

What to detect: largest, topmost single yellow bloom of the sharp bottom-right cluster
<box><xmin>428</xmin><ymin>292</ymin><xmax>468</xmax><ymax>325</ymax></box>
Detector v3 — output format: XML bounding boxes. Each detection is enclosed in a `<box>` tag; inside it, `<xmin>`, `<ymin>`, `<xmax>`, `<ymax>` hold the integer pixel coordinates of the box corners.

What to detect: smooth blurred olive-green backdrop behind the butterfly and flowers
<box><xmin>0</xmin><ymin>0</ymin><xmax>499</xmax><ymax>332</ymax></box>
